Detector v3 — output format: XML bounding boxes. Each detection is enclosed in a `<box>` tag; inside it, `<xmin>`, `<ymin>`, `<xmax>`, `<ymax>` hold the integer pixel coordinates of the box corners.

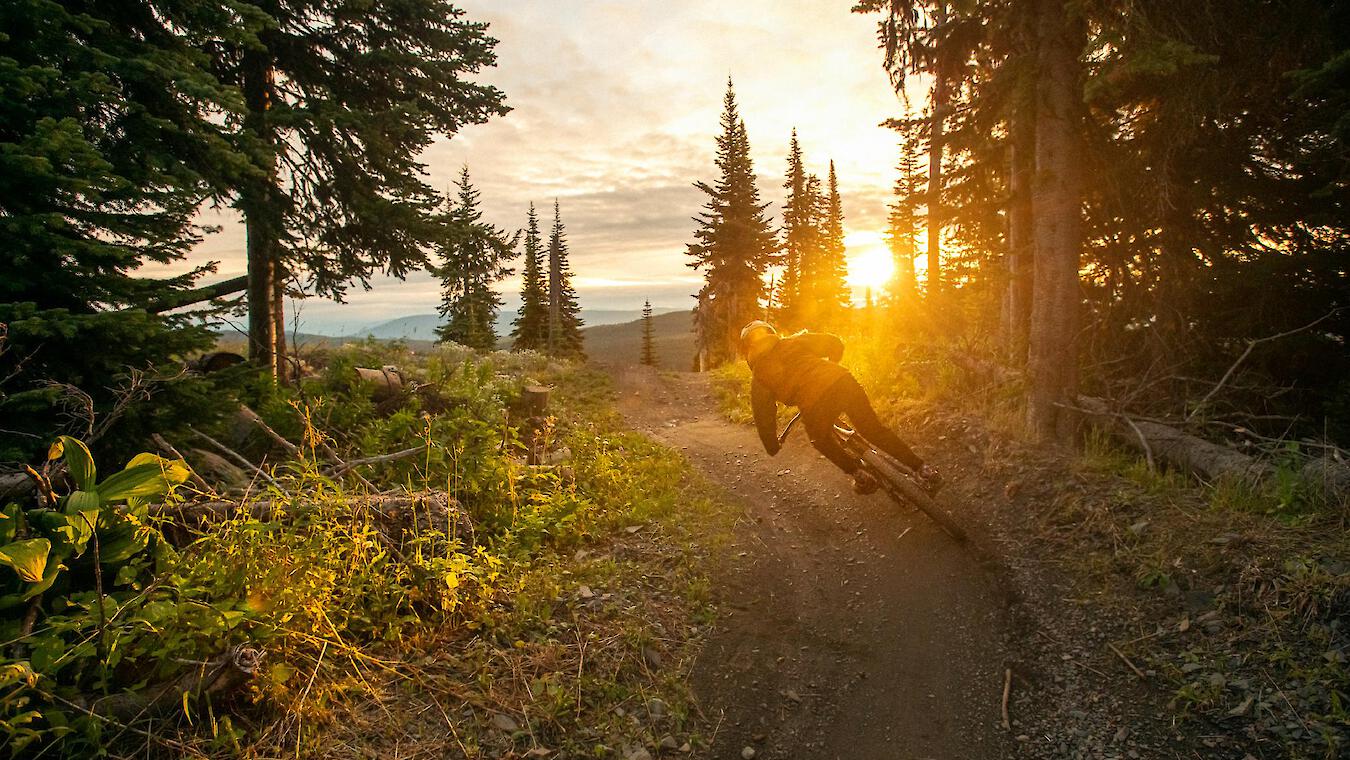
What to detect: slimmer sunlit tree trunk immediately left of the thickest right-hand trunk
<box><xmin>1003</xmin><ymin>74</ymin><xmax>1035</xmax><ymax>367</ymax></box>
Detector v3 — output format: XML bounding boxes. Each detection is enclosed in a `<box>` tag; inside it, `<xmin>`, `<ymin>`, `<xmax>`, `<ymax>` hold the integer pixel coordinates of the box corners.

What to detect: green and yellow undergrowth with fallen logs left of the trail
<box><xmin>0</xmin><ymin>343</ymin><xmax>725</xmax><ymax>757</ymax></box>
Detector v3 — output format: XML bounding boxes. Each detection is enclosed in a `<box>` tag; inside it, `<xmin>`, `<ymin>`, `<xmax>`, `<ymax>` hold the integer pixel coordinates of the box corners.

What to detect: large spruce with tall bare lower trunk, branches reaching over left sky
<box><xmin>216</xmin><ymin>0</ymin><xmax>508</xmax><ymax>371</ymax></box>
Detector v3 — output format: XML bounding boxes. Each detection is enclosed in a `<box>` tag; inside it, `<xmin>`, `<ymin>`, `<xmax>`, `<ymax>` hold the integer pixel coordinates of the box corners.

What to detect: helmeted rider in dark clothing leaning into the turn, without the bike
<box><xmin>740</xmin><ymin>320</ymin><xmax>942</xmax><ymax>494</ymax></box>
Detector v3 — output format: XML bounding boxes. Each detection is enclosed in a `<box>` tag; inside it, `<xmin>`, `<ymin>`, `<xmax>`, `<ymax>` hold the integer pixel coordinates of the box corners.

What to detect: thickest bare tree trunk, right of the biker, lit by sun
<box><xmin>1027</xmin><ymin>0</ymin><xmax>1085</xmax><ymax>443</ymax></box>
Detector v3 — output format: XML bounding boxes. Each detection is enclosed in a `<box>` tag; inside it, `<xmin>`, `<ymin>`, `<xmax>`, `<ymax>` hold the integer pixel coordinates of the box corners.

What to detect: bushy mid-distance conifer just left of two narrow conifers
<box><xmin>436</xmin><ymin>166</ymin><xmax>520</xmax><ymax>351</ymax></box>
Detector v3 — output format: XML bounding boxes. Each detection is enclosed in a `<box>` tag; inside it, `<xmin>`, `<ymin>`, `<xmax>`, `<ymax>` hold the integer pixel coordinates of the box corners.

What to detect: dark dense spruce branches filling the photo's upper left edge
<box><xmin>0</xmin><ymin>0</ymin><xmax>247</xmax><ymax>462</ymax></box>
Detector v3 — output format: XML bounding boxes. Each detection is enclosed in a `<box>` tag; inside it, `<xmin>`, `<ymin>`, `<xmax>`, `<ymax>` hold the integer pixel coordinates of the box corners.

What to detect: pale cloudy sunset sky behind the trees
<box><xmin>178</xmin><ymin>0</ymin><xmax>923</xmax><ymax>333</ymax></box>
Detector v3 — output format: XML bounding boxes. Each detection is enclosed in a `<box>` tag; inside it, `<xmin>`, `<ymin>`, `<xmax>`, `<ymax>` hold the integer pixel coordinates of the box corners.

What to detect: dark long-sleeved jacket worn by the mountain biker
<box><xmin>751</xmin><ymin>332</ymin><xmax>848</xmax><ymax>454</ymax></box>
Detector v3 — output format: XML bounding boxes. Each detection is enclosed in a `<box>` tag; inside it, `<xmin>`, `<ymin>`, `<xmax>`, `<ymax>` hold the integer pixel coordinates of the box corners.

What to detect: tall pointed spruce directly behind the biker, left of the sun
<box><xmin>687</xmin><ymin>80</ymin><xmax>778</xmax><ymax>364</ymax></box>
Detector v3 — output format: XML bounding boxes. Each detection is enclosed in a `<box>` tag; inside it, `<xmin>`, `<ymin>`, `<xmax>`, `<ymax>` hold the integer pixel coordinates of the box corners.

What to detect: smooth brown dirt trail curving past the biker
<box><xmin>616</xmin><ymin>369</ymin><xmax>1013</xmax><ymax>760</ymax></box>
